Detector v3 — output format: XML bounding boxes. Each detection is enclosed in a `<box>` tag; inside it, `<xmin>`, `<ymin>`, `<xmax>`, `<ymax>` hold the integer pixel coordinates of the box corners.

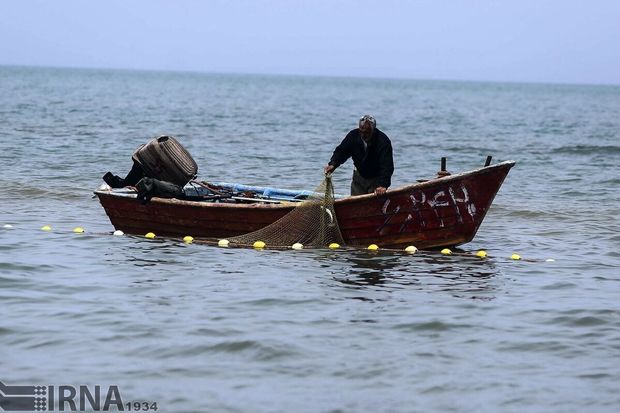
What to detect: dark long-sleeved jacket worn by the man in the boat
<box><xmin>329</xmin><ymin>128</ymin><xmax>394</xmax><ymax>188</ymax></box>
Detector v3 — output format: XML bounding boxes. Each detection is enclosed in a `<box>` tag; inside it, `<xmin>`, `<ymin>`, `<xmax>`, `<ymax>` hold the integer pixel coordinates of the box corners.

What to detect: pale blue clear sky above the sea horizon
<box><xmin>0</xmin><ymin>0</ymin><xmax>620</xmax><ymax>84</ymax></box>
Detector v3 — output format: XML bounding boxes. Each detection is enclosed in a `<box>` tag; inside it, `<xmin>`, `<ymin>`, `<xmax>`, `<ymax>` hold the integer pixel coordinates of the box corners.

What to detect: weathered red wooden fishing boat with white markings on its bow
<box><xmin>95</xmin><ymin>161</ymin><xmax>515</xmax><ymax>249</ymax></box>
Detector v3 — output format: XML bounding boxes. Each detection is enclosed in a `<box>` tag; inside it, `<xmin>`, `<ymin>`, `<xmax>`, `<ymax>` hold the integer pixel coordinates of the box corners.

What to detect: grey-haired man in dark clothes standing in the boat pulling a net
<box><xmin>325</xmin><ymin>115</ymin><xmax>394</xmax><ymax>195</ymax></box>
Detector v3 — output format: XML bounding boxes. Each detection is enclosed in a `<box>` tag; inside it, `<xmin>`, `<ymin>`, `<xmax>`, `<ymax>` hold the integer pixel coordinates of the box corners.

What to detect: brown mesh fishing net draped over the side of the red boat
<box><xmin>228</xmin><ymin>175</ymin><xmax>344</xmax><ymax>248</ymax></box>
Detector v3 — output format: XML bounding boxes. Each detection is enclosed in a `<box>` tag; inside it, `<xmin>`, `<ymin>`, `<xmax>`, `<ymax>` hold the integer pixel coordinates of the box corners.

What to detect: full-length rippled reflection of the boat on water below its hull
<box><xmin>100</xmin><ymin>237</ymin><xmax>503</xmax><ymax>300</ymax></box>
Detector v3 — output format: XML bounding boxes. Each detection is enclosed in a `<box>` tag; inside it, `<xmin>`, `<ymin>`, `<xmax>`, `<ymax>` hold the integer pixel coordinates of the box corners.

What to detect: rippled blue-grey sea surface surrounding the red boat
<box><xmin>0</xmin><ymin>67</ymin><xmax>620</xmax><ymax>412</ymax></box>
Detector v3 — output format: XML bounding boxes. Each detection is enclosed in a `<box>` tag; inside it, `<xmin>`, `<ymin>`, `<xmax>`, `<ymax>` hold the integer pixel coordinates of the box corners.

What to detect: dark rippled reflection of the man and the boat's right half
<box><xmin>316</xmin><ymin>250</ymin><xmax>501</xmax><ymax>300</ymax></box>
